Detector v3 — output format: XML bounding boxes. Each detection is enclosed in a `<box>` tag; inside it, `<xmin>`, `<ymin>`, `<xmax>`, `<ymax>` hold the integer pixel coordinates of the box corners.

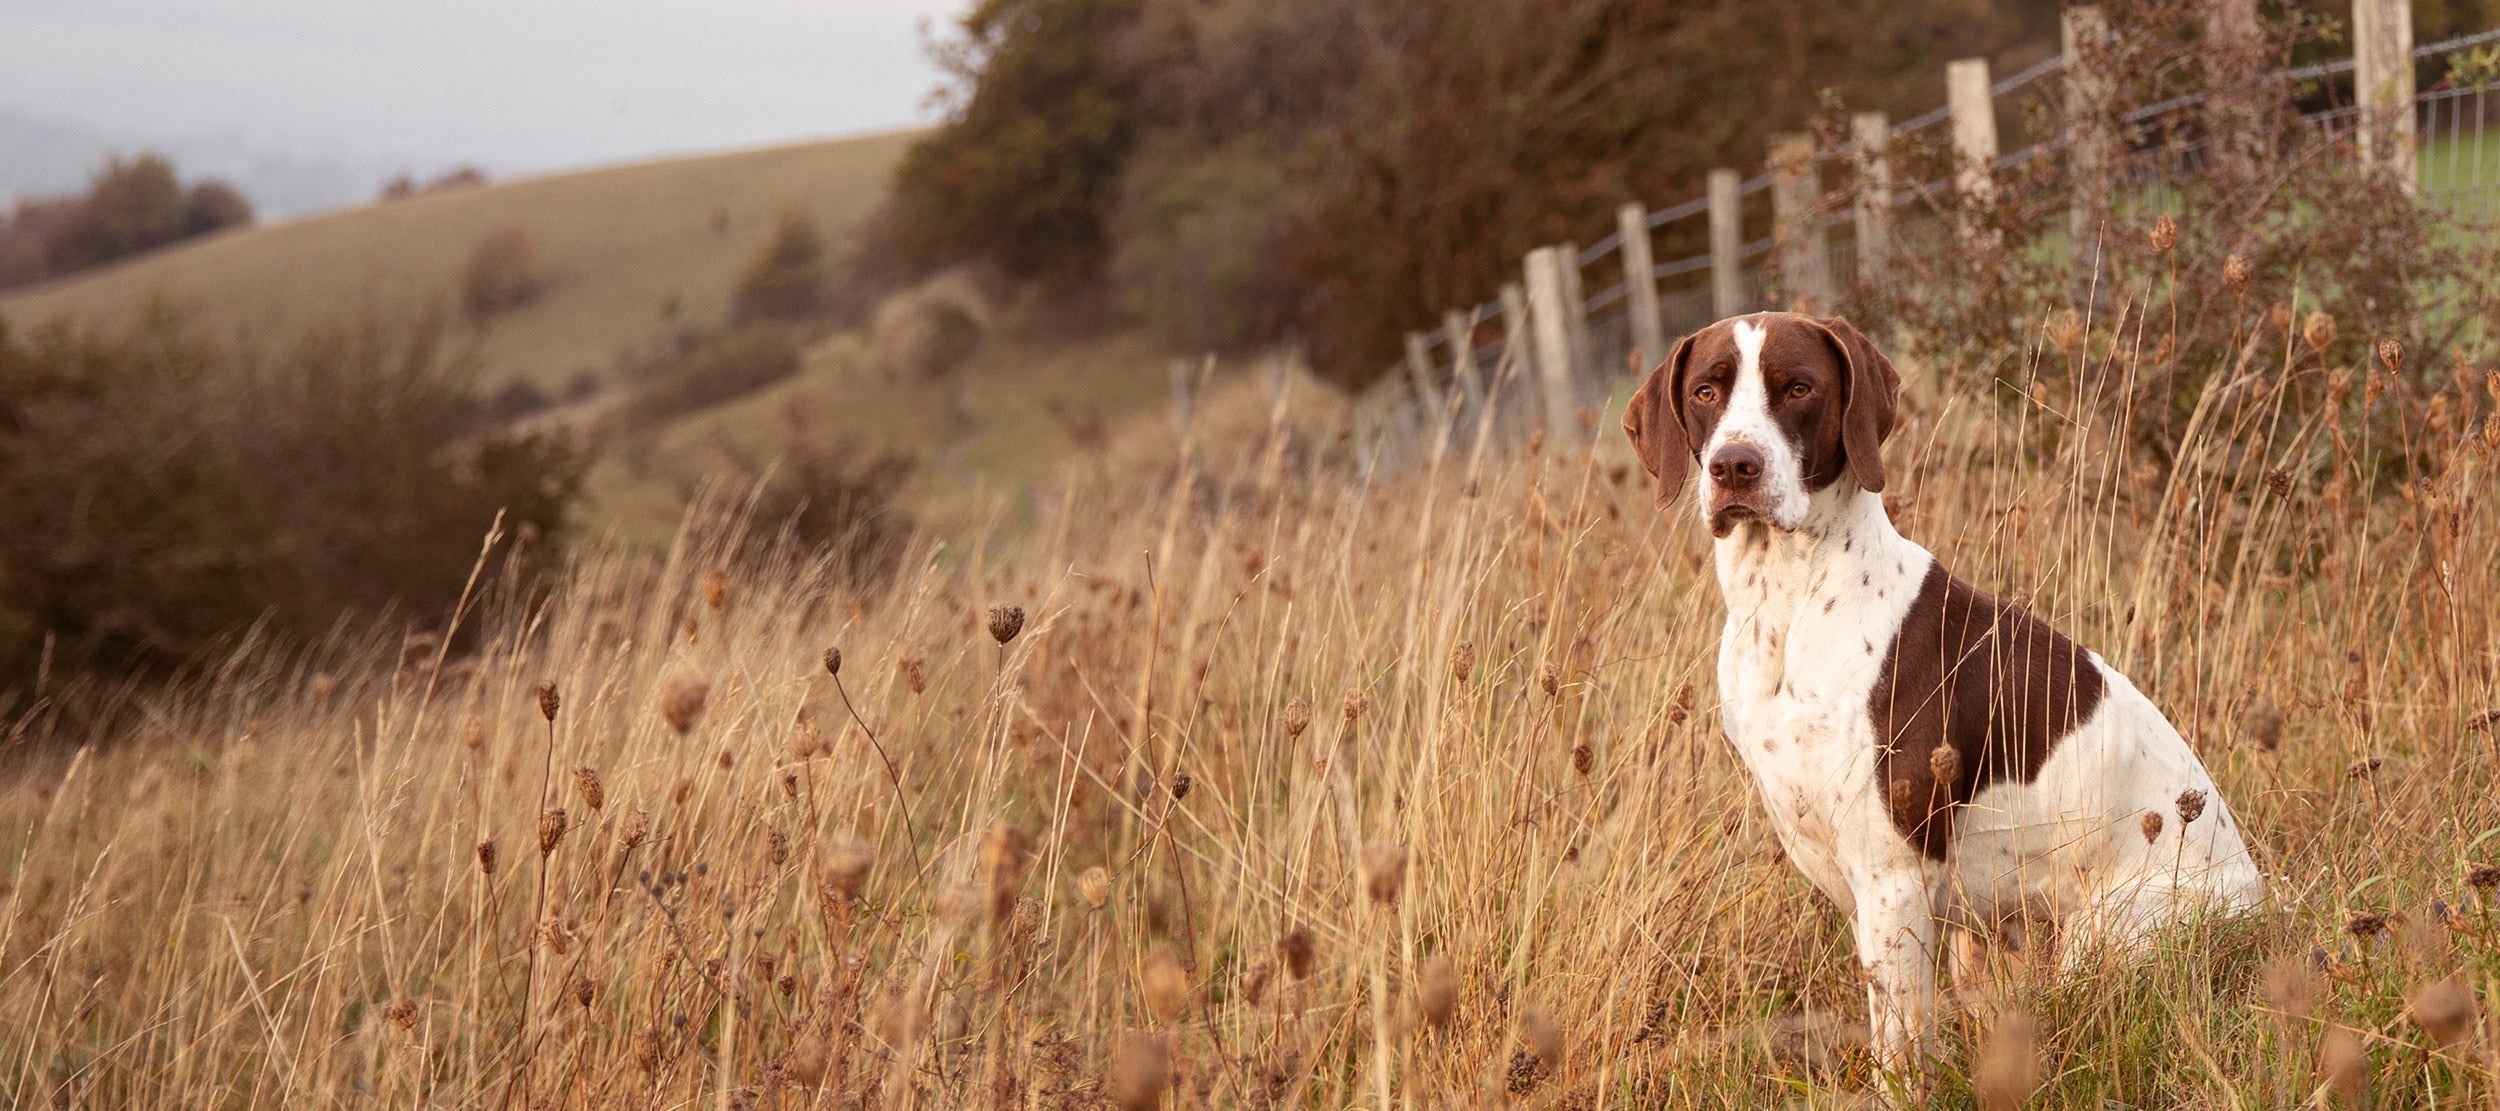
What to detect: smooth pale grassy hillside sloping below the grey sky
<box><xmin>0</xmin><ymin>133</ymin><xmax>913</xmax><ymax>388</ymax></box>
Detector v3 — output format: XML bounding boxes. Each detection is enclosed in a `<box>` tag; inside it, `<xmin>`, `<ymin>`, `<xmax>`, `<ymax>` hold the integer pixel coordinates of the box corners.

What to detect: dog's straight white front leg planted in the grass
<box><xmin>1850</xmin><ymin>861</ymin><xmax>1940</xmax><ymax>1073</ymax></box>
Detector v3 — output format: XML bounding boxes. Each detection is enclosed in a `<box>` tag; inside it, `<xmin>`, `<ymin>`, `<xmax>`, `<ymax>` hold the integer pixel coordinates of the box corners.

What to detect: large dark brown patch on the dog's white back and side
<box><xmin>1868</xmin><ymin>563</ymin><xmax>2103</xmax><ymax>861</ymax></box>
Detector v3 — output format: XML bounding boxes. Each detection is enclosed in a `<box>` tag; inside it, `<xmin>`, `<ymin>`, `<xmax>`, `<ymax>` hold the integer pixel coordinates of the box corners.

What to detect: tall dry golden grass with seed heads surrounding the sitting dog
<box><xmin>0</xmin><ymin>290</ymin><xmax>2500</xmax><ymax>1108</ymax></box>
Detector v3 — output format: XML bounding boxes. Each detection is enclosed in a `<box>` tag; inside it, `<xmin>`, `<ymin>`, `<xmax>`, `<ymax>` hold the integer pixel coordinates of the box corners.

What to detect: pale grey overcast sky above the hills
<box><xmin>0</xmin><ymin>0</ymin><xmax>968</xmax><ymax>191</ymax></box>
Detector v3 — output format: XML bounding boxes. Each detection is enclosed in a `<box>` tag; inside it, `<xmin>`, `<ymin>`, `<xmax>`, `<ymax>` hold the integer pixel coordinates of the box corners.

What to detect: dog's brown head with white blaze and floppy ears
<box><xmin>1623</xmin><ymin>313</ymin><xmax>1900</xmax><ymax>535</ymax></box>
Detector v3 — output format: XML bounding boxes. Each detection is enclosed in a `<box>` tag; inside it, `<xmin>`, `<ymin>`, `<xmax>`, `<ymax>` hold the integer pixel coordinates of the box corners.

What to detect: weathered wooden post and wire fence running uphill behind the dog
<box><xmin>1355</xmin><ymin>0</ymin><xmax>2500</xmax><ymax>468</ymax></box>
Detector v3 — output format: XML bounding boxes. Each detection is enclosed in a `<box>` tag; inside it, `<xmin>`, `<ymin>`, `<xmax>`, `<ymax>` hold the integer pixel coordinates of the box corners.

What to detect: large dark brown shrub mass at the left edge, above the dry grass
<box><xmin>0</xmin><ymin>313</ymin><xmax>585</xmax><ymax>691</ymax></box>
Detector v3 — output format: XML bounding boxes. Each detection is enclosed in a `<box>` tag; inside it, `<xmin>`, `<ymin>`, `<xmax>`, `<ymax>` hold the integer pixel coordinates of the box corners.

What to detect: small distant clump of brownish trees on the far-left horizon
<box><xmin>0</xmin><ymin>155</ymin><xmax>253</xmax><ymax>288</ymax></box>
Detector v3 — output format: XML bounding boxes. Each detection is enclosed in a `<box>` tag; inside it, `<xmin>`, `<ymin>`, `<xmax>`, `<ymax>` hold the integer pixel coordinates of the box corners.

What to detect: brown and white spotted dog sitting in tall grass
<box><xmin>1623</xmin><ymin>313</ymin><xmax>2258</xmax><ymax>1068</ymax></box>
